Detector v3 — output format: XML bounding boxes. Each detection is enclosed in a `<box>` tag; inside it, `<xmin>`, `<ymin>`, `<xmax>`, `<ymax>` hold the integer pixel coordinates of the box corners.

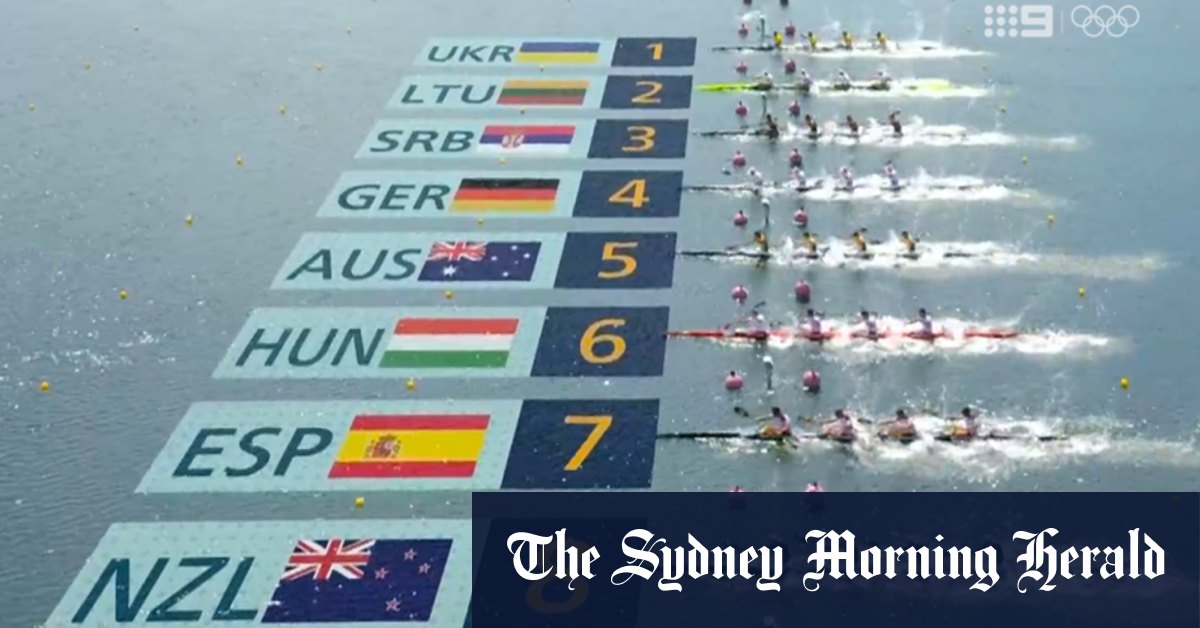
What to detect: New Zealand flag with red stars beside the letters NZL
<box><xmin>263</xmin><ymin>539</ymin><xmax>450</xmax><ymax>623</ymax></box>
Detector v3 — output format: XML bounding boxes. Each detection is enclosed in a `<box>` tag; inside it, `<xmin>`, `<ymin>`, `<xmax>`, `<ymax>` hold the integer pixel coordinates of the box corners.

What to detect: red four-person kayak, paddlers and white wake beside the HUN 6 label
<box><xmin>668</xmin><ymin>316</ymin><xmax>1115</xmax><ymax>357</ymax></box>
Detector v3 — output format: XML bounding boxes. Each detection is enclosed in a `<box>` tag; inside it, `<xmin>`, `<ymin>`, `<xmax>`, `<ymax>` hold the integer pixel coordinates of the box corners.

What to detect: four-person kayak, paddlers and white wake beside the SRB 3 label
<box><xmin>697</xmin><ymin>116</ymin><xmax>1082</xmax><ymax>150</ymax></box>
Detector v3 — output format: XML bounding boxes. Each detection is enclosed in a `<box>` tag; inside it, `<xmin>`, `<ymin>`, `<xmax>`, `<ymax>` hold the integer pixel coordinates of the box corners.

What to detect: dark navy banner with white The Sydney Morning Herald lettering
<box><xmin>470</xmin><ymin>492</ymin><xmax>1200</xmax><ymax>628</ymax></box>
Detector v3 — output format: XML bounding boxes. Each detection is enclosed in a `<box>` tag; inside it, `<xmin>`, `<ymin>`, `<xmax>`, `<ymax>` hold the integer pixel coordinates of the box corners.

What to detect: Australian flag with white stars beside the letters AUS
<box><xmin>416</xmin><ymin>243</ymin><xmax>541</xmax><ymax>281</ymax></box>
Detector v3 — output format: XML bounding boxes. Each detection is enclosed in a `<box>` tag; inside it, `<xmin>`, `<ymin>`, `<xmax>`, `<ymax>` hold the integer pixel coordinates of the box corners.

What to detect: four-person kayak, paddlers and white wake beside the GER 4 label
<box><xmin>684</xmin><ymin>169</ymin><xmax>1037</xmax><ymax>203</ymax></box>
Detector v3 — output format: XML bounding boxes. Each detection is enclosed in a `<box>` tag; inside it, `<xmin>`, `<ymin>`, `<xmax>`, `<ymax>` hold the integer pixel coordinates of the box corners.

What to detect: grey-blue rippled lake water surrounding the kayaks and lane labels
<box><xmin>0</xmin><ymin>0</ymin><xmax>1200</xmax><ymax>626</ymax></box>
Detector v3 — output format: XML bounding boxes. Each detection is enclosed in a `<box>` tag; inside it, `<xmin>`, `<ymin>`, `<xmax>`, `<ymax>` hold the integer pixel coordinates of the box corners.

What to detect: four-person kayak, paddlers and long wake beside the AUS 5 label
<box><xmin>679</xmin><ymin>233</ymin><xmax>1164</xmax><ymax>280</ymax></box>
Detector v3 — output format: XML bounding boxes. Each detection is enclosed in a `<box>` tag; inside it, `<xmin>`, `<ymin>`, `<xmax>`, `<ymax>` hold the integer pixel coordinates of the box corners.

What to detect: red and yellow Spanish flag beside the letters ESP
<box><xmin>329</xmin><ymin>414</ymin><xmax>488</xmax><ymax>479</ymax></box>
